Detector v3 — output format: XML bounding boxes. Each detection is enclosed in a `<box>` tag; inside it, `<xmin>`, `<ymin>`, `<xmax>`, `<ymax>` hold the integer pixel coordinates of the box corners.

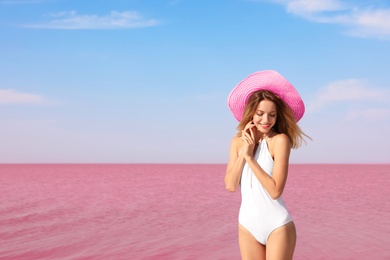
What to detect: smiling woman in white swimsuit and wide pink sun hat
<box><xmin>225</xmin><ymin>70</ymin><xmax>306</xmax><ymax>259</ymax></box>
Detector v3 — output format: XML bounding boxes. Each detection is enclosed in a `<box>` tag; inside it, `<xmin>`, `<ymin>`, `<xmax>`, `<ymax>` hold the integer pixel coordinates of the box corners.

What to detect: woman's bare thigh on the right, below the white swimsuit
<box><xmin>266</xmin><ymin>222</ymin><xmax>297</xmax><ymax>260</ymax></box>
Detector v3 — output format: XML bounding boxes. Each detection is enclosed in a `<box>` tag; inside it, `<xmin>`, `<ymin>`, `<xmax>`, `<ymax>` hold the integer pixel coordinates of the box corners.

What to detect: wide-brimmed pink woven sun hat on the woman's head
<box><xmin>227</xmin><ymin>70</ymin><xmax>305</xmax><ymax>122</ymax></box>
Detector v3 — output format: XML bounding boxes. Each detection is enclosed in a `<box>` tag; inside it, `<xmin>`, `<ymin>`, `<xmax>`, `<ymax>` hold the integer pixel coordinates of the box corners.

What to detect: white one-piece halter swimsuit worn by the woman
<box><xmin>238</xmin><ymin>139</ymin><xmax>292</xmax><ymax>245</ymax></box>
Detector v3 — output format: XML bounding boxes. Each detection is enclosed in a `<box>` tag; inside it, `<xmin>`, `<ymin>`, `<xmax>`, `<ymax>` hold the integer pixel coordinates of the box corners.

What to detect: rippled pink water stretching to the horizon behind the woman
<box><xmin>0</xmin><ymin>164</ymin><xmax>390</xmax><ymax>260</ymax></box>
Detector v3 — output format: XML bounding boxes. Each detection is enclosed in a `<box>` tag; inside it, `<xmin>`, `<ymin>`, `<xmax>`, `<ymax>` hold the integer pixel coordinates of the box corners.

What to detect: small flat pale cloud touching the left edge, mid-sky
<box><xmin>0</xmin><ymin>89</ymin><xmax>44</xmax><ymax>105</ymax></box>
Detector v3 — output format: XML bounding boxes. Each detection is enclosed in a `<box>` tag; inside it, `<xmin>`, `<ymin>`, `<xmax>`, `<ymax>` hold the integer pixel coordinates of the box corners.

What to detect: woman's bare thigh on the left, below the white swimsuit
<box><xmin>238</xmin><ymin>225</ymin><xmax>265</xmax><ymax>260</ymax></box>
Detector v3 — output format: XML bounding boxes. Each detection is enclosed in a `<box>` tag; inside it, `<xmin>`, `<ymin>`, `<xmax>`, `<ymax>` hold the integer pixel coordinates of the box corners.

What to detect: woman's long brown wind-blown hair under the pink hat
<box><xmin>237</xmin><ymin>90</ymin><xmax>310</xmax><ymax>149</ymax></box>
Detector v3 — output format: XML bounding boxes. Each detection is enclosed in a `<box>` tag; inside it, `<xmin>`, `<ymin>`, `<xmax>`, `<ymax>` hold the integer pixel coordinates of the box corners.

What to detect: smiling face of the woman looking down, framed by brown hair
<box><xmin>253</xmin><ymin>100</ymin><xmax>277</xmax><ymax>134</ymax></box>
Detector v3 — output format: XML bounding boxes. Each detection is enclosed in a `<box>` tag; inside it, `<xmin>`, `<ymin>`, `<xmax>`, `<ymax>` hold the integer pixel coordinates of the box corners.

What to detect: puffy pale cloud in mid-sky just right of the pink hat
<box><xmin>308</xmin><ymin>79</ymin><xmax>388</xmax><ymax>110</ymax></box>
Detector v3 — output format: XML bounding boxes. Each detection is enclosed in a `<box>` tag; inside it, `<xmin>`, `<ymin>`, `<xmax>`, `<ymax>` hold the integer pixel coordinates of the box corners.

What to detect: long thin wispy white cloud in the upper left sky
<box><xmin>24</xmin><ymin>11</ymin><xmax>159</xmax><ymax>30</ymax></box>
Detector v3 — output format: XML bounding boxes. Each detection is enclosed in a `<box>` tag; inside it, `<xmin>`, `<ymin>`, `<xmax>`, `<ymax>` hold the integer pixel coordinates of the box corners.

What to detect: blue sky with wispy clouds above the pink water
<box><xmin>0</xmin><ymin>0</ymin><xmax>390</xmax><ymax>163</ymax></box>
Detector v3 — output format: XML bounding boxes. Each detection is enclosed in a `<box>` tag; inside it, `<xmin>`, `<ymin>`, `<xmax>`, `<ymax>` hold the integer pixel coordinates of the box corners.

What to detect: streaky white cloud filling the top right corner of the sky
<box><xmin>264</xmin><ymin>0</ymin><xmax>390</xmax><ymax>39</ymax></box>
